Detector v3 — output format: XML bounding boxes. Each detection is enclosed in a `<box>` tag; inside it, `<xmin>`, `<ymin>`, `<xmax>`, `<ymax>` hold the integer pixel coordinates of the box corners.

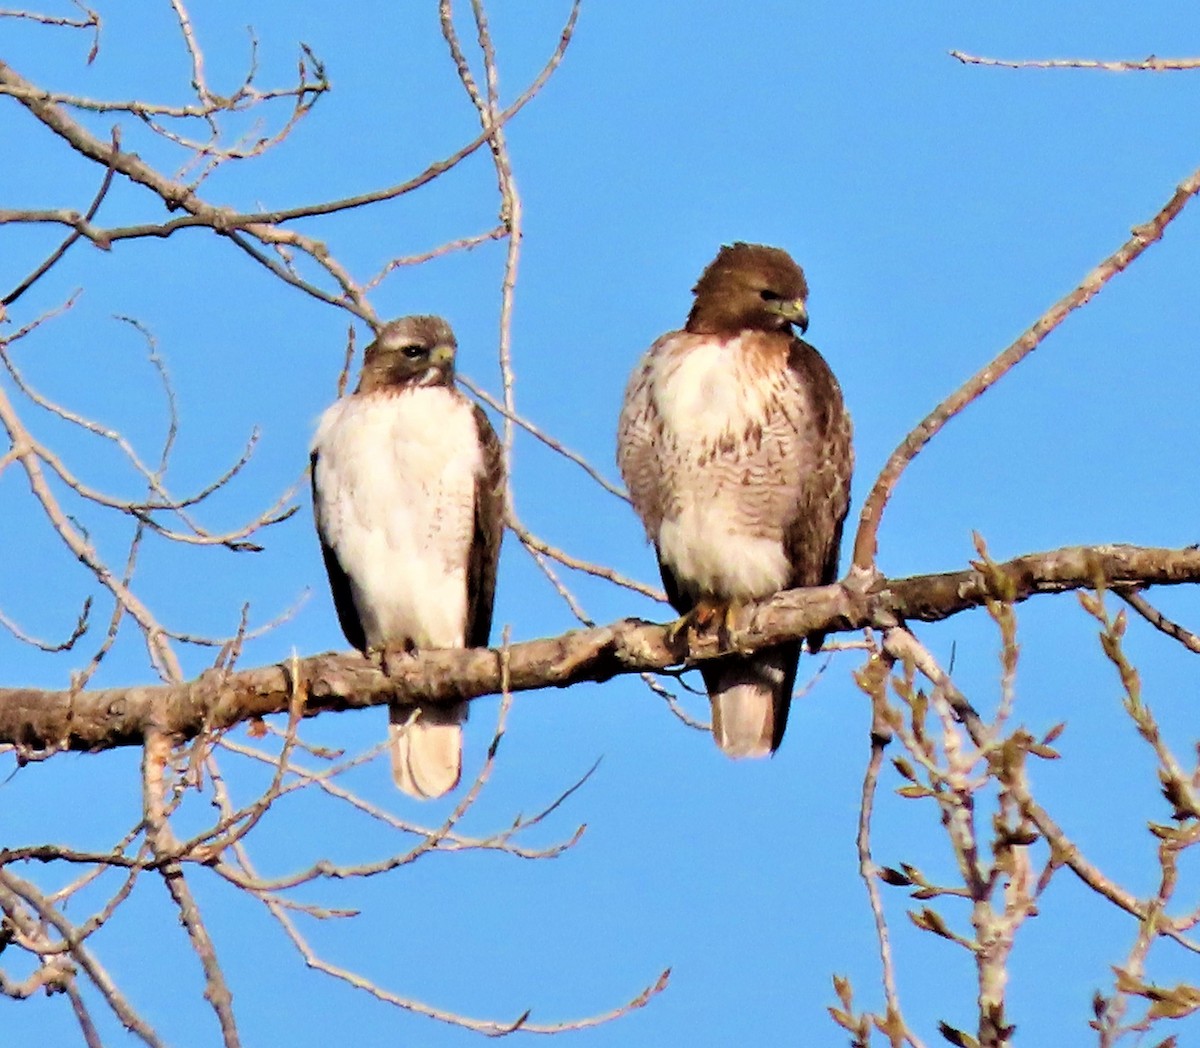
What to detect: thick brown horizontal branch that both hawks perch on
<box><xmin>7</xmin><ymin>545</ymin><xmax>1200</xmax><ymax>755</ymax></box>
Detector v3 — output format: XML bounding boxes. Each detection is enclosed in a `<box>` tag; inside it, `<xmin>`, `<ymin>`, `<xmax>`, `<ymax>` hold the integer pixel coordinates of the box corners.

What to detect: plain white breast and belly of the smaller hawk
<box><xmin>313</xmin><ymin>387</ymin><xmax>482</xmax><ymax>648</ymax></box>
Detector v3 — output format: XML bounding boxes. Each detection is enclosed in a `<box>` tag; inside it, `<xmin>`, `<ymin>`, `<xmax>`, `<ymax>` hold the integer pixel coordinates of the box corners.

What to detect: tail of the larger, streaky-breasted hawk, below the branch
<box><xmin>702</xmin><ymin>643</ymin><xmax>800</xmax><ymax>757</ymax></box>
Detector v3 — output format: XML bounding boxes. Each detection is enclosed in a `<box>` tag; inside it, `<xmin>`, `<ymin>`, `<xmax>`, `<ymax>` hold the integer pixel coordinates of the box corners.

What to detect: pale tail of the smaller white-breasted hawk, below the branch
<box><xmin>388</xmin><ymin>702</ymin><xmax>467</xmax><ymax>801</ymax></box>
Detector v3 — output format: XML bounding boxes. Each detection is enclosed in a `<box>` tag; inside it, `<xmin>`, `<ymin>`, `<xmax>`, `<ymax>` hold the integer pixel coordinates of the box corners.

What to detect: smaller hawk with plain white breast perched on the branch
<box><xmin>312</xmin><ymin>317</ymin><xmax>504</xmax><ymax>797</ymax></box>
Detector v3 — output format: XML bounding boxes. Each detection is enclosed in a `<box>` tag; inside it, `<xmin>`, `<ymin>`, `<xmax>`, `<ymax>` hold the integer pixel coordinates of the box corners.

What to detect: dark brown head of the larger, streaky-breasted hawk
<box><xmin>686</xmin><ymin>241</ymin><xmax>809</xmax><ymax>335</ymax></box>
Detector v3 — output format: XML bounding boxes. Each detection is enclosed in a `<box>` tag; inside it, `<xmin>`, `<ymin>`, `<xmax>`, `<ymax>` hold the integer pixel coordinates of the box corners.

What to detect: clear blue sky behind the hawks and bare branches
<box><xmin>0</xmin><ymin>0</ymin><xmax>1200</xmax><ymax>1048</ymax></box>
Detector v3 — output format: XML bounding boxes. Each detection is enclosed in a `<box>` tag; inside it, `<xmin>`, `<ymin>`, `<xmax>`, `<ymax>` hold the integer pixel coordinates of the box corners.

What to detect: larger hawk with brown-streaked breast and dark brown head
<box><xmin>617</xmin><ymin>242</ymin><xmax>853</xmax><ymax>757</ymax></box>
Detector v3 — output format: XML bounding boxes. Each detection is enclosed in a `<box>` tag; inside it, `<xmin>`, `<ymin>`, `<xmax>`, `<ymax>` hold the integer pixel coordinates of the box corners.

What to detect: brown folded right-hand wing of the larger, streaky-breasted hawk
<box><xmin>784</xmin><ymin>339</ymin><xmax>854</xmax><ymax>652</ymax></box>
